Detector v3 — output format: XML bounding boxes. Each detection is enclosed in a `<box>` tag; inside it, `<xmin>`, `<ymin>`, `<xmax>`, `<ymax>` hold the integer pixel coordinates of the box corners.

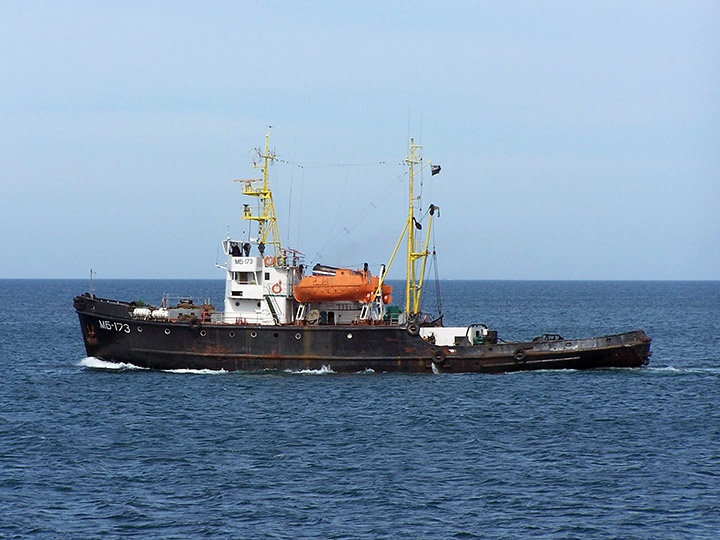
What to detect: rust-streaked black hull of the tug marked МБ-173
<box><xmin>75</xmin><ymin>296</ymin><xmax>650</xmax><ymax>373</ymax></box>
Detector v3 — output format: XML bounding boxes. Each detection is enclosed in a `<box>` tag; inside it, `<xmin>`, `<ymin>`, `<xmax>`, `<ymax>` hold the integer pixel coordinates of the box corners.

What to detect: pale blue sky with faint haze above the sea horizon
<box><xmin>0</xmin><ymin>0</ymin><xmax>720</xmax><ymax>279</ymax></box>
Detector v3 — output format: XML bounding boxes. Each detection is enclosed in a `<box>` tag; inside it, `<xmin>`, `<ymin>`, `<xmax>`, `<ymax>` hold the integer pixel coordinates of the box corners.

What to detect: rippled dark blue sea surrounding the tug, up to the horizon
<box><xmin>0</xmin><ymin>280</ymin><xmax>720</xmax><ymax>539</ymax></box>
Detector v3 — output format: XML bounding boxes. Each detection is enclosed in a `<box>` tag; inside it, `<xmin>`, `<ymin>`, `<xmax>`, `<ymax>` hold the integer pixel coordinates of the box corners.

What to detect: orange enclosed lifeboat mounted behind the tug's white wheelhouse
<box><xmin>293</xmin><ymin>268</ymin><xmax>392</xmax><ymax>304</ymax></box>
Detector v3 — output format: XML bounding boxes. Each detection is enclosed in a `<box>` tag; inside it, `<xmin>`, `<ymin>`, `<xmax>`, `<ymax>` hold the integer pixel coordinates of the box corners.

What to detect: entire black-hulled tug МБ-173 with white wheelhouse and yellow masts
<box><xmin>74</xmin><ymin>131</ymin><xmax>650</xmax><ymax>373</ymax></box>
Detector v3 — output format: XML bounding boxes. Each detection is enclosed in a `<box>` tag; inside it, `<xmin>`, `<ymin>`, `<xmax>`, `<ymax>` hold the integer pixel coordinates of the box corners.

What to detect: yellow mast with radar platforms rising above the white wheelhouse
<box><xmin>235</xmin><ymin>126</ymin><xmax>283</xmax><ymax>264</ymax></box>
